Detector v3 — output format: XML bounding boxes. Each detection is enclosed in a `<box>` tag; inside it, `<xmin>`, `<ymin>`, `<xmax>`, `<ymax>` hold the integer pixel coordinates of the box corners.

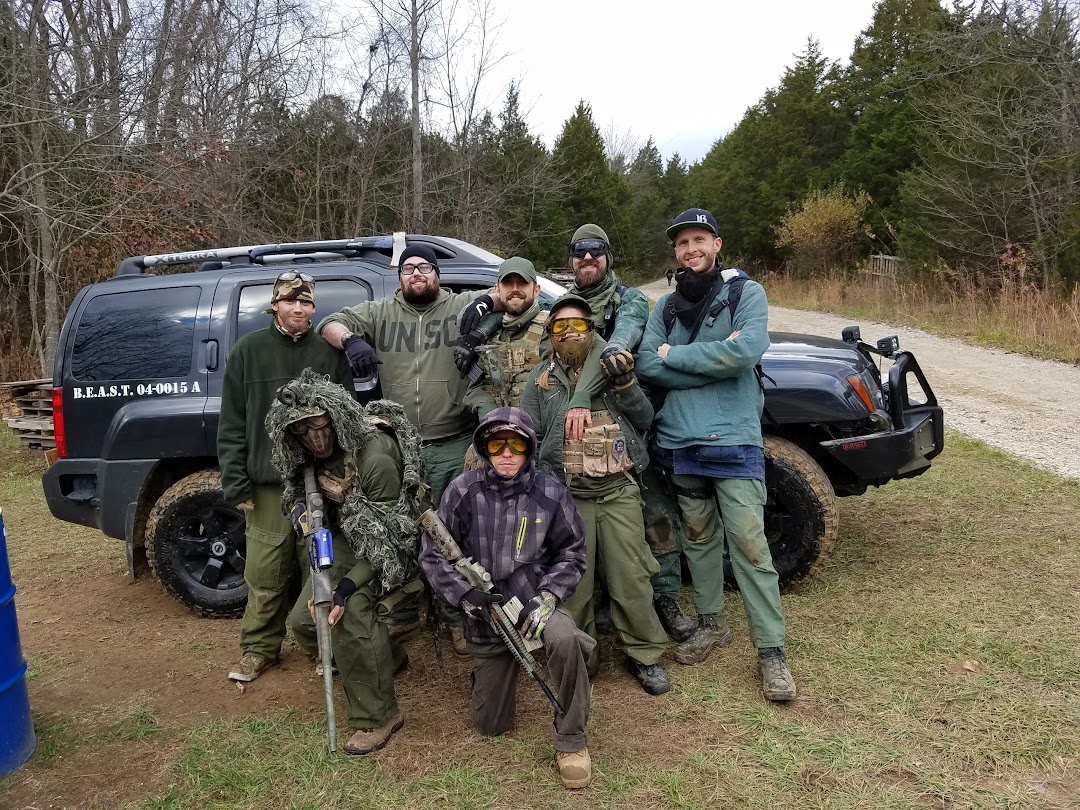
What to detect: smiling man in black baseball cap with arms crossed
<box><xmin>637</xmin><ymin>208</ymin><xmax>796</xmax><ymax>701</ymax></box>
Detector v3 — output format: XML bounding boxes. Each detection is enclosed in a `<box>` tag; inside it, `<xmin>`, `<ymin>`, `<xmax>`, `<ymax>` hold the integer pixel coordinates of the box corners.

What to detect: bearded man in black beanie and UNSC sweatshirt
<box><xmin>319</xmin><ymin>244</ymin><xmax>501</xmax><ymax>656</ymax></box>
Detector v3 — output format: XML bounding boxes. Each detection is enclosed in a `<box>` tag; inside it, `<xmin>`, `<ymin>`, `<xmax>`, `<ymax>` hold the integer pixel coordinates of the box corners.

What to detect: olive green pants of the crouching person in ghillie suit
<box><xmin>288</xmin><ymin>535</ymin><xmax>397</xmax><ymax>729</ymax></box>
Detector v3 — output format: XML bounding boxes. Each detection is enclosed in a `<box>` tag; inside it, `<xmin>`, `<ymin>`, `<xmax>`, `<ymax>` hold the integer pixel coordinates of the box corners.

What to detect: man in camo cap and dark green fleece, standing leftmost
<box><xmin>217</xmin><ymin>270</ymin><xmax>352</xmax><ymax>681</ymax></box>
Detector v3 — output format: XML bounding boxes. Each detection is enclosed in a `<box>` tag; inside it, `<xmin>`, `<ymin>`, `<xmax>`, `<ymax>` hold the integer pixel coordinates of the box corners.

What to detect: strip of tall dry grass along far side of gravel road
<box><xmin>762</xmin><ymin>272</ymin><xmax>1080</xmax><ymax>363</ymax></box>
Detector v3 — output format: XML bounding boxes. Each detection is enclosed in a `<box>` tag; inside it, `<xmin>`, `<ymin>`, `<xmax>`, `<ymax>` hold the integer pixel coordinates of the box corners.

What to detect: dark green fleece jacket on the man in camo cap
<box><xmin>217</xmin><ymin>320</ymin><xmax>352</xmax><ymax>504</ymax></box>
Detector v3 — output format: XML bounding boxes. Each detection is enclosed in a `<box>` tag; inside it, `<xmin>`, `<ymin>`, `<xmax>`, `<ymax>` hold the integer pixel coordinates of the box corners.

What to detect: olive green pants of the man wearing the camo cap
<box><xmin>240</xmin><ymin>484</ymin><xmax>308</xmax><ymax>661</ymax></box>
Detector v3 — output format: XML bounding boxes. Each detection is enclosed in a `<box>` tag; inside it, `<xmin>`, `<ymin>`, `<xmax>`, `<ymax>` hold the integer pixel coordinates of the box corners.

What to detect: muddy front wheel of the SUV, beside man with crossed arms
<box><xmin>765</xmin><ymin>435</ymin><xmax>839</xmax><ymax>588</ymax></box>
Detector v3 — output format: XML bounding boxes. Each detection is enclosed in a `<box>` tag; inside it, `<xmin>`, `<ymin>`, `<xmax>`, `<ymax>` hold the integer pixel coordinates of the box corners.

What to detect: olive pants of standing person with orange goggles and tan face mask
<box><xmin>566</xmin><ymin>483</ymin><xmax>667</xmax><ymax>664</ymax></box>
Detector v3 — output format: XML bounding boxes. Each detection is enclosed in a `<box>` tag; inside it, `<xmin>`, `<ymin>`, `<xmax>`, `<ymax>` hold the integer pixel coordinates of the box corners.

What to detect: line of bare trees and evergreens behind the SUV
<box><xmin>0</xmin><ymin>0</ymin><xmax>1080</xmax><ymax>377</ymax></box>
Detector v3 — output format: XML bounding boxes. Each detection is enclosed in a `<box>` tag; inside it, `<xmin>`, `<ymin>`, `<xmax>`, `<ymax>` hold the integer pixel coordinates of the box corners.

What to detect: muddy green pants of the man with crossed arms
<box><xmin>672</xmin><ymin>474</ymin><xmax>784</xmax><ymax>648</ymax></box>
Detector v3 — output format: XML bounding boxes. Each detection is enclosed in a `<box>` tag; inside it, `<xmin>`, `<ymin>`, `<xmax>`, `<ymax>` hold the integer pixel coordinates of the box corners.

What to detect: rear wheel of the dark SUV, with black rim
<box><xmin>146</xmin><ymin>469</ymin><xmax>247</xmax><ymax>617</ymax></box>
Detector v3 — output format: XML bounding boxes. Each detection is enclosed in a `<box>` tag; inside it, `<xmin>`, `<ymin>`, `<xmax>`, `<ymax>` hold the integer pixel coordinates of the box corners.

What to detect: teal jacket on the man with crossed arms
<box><xmin>635</xmin><ymin>281</ymin><xmax>769</xmax><ymax>449</ymax></box>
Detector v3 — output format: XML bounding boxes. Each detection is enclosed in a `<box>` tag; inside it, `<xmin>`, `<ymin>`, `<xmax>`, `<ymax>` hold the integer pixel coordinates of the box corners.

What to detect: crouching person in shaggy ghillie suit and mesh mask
<box><xmin>266</xmin><ymin>369</ymin><xmax>423</xmax><ymax>754</ymax></box>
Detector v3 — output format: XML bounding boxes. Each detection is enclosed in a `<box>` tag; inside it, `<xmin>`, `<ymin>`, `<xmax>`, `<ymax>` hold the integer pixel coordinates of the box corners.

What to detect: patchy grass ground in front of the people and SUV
<box><xmin>0</xmin><ymin>433</ymin><xmax>1080</xmax><ymax>810</ymax></box>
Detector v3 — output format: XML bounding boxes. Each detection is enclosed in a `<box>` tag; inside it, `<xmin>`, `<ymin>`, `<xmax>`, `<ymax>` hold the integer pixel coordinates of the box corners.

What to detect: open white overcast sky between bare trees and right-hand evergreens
<box><xmin>477</xmin><ymin>0</ymin><xmax>875</xmax><ymax>162</ymax></box>
